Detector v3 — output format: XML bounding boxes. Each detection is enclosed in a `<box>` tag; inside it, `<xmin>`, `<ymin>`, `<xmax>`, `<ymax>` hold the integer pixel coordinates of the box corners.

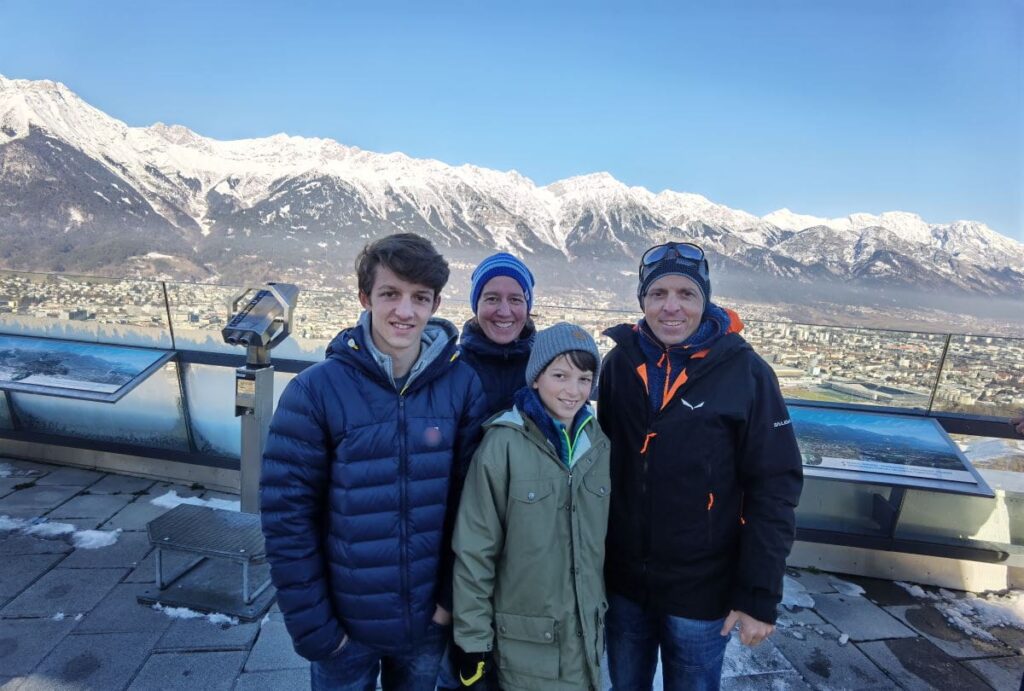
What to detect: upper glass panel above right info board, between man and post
<box><xmin>743</xmin><ymin>321</ymin><xmax>946</xmax><ymax>411</ymax></box>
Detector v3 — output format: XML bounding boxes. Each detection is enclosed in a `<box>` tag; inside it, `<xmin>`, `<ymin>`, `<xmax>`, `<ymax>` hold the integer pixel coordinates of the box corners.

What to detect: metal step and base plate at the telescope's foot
<box><xmin>138</xmin><ymin>504</ymin><xmax>274</xmax><ymax>621</ymax></box>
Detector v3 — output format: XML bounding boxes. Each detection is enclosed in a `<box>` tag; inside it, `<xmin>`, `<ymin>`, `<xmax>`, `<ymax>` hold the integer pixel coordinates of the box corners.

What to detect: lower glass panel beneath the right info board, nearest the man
<box><xmin>797</xmin><ymin>477</ymin><xmax>891</xmax><ymax>535</ymax></box>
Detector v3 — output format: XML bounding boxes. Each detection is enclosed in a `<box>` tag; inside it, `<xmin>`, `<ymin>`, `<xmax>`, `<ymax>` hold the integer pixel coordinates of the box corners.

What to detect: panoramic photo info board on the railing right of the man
<box><xmin>788</xmin><ymin>404</ymin><xmax>993</xmax><ymax>496</ymax></box>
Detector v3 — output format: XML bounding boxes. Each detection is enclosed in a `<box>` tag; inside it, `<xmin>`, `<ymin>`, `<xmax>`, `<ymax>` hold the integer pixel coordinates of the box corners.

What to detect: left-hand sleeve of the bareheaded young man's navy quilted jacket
<box><xmin>260</xmin><ymin>376</ymin><xmax>345</xmax><ymax>660</ymax></box>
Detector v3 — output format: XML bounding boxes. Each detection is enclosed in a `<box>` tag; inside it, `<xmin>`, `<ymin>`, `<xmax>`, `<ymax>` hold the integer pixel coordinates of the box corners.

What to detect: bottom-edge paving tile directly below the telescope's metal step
<box><xmin>128</xmin><ymin>651</ymin><xmax>246</xmax><ymax>691</ymax></box>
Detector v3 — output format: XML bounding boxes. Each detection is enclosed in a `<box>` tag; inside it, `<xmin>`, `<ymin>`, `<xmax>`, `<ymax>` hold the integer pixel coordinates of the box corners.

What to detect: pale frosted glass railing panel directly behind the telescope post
<box><xmin>184</xmin><ymin>364</ymin><xmax>295</xmax><ymax>459</ymax></box>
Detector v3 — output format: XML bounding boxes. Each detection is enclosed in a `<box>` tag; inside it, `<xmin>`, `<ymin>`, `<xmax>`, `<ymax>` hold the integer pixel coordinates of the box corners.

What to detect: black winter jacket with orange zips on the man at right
<box><xmin>597</xmin><ymin>319</ymin><xmax>803</xmax><ymax>623</ymax></box>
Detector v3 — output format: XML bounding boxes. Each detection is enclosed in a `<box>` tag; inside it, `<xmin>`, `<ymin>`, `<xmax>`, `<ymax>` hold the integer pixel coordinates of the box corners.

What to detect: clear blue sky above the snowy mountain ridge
<box><xmin>0</xmin><ymin>0</ymin><xmax>1024</xmax><ymax>240</ymax></box>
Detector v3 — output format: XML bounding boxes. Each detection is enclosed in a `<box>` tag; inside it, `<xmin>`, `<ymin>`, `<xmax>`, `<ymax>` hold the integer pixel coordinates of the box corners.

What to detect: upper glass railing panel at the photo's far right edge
<box><xmin>933</xmin><ymin>336</ymin><xmax>1024</xmax><ymax>418</ymax></box>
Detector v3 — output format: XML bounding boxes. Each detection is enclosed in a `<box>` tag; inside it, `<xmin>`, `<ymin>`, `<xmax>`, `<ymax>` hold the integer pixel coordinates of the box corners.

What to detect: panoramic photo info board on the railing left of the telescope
<box><xmin>0</xmin><ymin>336</ymin><xmax>174</xmax><ymax>403</ymax></box>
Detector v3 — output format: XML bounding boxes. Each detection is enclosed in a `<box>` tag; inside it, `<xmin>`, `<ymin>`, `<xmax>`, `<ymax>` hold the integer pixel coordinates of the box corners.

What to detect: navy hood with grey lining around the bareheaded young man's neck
<box><xmin>327</xmin><ymin>310</ymin><xmax>459</xmax><ymax>389</ymax></box>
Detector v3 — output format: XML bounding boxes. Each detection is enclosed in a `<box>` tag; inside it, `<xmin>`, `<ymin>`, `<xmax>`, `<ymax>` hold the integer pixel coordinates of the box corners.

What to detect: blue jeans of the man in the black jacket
<box><xmin>605</xmin><ymin>593</ymin><xmax>729</xmax><ymax>691</ymax></box>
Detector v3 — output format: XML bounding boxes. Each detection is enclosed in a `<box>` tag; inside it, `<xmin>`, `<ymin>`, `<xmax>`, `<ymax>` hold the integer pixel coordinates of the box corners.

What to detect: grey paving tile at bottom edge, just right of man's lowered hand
<box><xmin>771</xmin><ymin>625</ymin><xmax>893</xmax><ymax>691</ymax></box>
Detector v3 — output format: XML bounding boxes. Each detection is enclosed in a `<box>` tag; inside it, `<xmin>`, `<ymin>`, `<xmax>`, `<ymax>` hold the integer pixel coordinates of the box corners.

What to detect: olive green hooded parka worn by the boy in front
<box><xmin>453</xmin><ymin>407</ymin><xmax>610</xmax><ymax>690</ymax></box>
